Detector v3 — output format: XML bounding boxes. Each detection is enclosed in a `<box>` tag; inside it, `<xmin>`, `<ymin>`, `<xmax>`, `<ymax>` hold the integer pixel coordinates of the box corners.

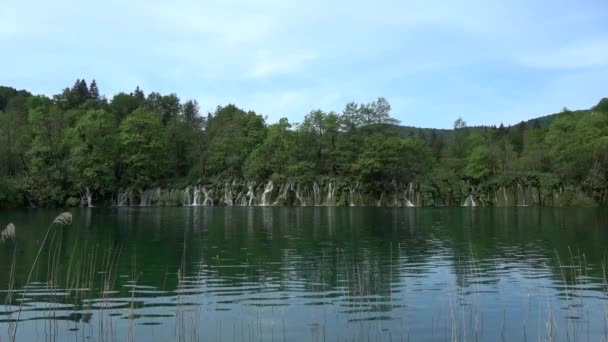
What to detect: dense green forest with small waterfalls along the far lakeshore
<box><xmin>0</xmin><ymin>80</ymin><xmax>608</xmax><ymax>207</ymax></box>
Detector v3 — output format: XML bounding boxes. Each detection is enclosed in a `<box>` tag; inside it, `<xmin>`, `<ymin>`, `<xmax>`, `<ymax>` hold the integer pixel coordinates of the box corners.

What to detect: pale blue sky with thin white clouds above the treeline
<box><xmin>0</xmin><ymin>0</ymin><xmax>608</xmax><ymax>128</ymax></box>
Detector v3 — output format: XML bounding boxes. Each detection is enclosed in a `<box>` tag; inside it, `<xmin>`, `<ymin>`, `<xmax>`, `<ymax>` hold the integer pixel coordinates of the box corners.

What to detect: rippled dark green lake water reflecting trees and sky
<box><xmin>0</xmin><ymin>207</ymin><xmax>608</xmax><ymax>341</ymax></box>
